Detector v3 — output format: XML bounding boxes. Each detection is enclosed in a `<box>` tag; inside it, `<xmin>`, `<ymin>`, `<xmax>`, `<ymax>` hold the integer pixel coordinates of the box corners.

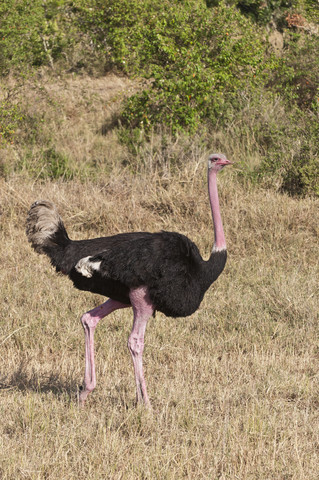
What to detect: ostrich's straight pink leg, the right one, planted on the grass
<box><xmin>128</xmin><ymin>287</ymin><xmax>154</xmax><ymax>408</ymax></box>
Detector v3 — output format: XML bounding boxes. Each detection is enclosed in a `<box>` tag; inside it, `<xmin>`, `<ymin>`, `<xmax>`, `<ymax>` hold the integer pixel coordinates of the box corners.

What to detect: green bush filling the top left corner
<box><xmin>0</xmin><ymin>0</ymin><xmax>79</xmax><ymax>75</ymax></box>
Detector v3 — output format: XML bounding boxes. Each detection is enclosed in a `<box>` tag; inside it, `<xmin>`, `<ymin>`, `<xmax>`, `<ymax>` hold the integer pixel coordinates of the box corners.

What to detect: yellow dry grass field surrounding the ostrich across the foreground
<box><xmin>0</xmin><ymin>75</ymin><xmax>319</xmax><ymax>480</ymax></box>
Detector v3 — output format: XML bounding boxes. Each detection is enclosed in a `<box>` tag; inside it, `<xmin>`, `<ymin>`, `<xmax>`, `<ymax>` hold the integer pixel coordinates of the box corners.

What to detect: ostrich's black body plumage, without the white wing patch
<box><xmin>27</xmin><ymin>202</ymin><xmax>227</xmax><ymax>317</ymax></box>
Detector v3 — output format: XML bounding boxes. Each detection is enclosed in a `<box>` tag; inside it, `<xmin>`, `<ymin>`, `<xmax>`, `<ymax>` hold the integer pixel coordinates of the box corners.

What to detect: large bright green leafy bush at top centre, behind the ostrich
<box><xmin>79</xmin><ymin>0</ymin><xmax>276</xmax><ymax>132</ymax></box>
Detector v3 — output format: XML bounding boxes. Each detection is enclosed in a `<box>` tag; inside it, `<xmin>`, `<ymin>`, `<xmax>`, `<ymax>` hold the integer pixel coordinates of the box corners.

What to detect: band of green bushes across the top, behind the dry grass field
<box><xmin>0</xmin><ymin>0</ymin><xmax>319</xmax><ymax>195</ymax></box>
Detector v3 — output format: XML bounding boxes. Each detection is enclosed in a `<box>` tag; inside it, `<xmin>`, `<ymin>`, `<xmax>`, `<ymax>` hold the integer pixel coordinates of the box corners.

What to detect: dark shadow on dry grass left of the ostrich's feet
<box><xmin>0</xmin><ymin>360</ymin><xmax>79</xmax><ymax>399</ymax></box>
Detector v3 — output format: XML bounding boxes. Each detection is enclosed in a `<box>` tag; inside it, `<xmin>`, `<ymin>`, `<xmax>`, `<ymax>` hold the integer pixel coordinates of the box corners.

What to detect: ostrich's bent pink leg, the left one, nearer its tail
<box><xmin>79</xmin><ymin>299</ymin><xmax>130</xmax><ymax>406</ymax></box>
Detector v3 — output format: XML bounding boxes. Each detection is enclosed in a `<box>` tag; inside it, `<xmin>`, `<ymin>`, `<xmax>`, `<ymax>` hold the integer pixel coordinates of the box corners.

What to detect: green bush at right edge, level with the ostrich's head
<box><xmin>250</xmin><ymin>107</ymin><xmax>319</xmax><ymax>196</ymax></box>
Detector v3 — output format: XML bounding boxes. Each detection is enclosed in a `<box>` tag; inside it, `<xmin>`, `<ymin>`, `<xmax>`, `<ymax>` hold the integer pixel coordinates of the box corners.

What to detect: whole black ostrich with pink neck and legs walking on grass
<box><xmin>26</xmin><ymin>154</ymin><xmax>231</xmax><ymax>407</ymax></box>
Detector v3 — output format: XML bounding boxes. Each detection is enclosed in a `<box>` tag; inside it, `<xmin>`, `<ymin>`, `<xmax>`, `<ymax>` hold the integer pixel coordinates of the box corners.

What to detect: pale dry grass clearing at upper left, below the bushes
<box><xmin>0</xmin><ymin>73</ymin><xmax>138</xmax><ymax>177</ymax></box>
